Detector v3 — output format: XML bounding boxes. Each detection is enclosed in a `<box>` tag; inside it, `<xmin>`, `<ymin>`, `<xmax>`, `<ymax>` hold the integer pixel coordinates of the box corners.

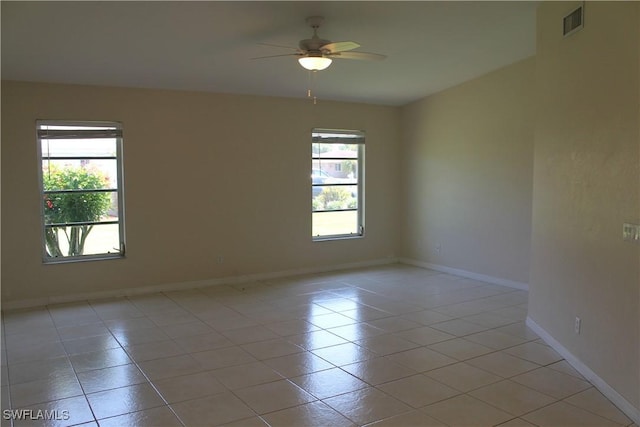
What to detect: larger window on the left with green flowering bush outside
<box><xmin>37</xmin><ymin>121</ymin><xmax>124</xmax><ymax>262</ymax></box>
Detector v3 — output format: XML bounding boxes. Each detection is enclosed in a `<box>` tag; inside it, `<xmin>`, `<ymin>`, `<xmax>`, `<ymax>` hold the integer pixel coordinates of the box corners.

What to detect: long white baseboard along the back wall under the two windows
<box><xmin>2</xmin><ymin>258</ymin><xmax>398</xmax><ymax>310</ymax></box>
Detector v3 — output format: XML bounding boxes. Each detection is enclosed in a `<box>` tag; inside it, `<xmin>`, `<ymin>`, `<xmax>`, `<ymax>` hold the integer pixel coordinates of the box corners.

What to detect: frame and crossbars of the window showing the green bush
<box><xmin>36</xmin><ymin>120</ymin><xmax>125</xmax><ymax>264</ymax></box>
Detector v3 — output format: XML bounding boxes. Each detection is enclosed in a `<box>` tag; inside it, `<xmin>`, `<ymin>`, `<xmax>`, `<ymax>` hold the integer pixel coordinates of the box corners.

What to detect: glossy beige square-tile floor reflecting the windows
<box><xmin>2</xmin><ymin>265</ymin><xmax>637</xmax><ymax>427</ymax></box>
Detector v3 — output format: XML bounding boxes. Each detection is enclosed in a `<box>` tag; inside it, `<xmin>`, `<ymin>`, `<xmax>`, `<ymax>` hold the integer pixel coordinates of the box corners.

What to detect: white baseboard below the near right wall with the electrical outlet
<box><xmin>527</xmin><ymin>316</ymin><xmax>640</xmax><ymax>424</ymax></box>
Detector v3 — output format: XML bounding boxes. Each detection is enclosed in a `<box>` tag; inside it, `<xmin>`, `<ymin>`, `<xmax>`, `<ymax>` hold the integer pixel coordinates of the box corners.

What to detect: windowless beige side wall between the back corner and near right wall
<box><xmin>401</xmin><ymin>58</ymin><xmax>535</xmax><ymax>284</ymax></box>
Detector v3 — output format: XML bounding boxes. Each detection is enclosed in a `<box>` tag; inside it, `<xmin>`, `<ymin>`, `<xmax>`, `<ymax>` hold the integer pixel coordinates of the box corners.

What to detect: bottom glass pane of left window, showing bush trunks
<box><xmin>45</xmin><ymin>224</ymin><xmax>120</xmax><ymax>258</ymax></box>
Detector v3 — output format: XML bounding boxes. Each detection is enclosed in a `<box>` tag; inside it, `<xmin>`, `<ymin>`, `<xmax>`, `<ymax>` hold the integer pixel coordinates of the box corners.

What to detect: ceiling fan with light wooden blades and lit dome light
<box><xmin>253</xmin><ymin>16</ymin><xmax>386</xmax><ymax>71</ymax></box>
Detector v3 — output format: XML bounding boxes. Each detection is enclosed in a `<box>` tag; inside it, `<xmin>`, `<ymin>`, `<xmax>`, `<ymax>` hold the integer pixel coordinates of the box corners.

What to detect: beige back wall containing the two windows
<box><xmin>2</xmin><ymin>82</ymin><xmax>399</xmax><ymax>303</ymax></box>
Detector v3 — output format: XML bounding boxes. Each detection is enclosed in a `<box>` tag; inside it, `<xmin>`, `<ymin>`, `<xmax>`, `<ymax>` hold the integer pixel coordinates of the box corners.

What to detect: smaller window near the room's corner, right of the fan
<box><xmin>311</xmin><ymin>129</ymin><xmax>364</xmax><ymax>240</ymax></box>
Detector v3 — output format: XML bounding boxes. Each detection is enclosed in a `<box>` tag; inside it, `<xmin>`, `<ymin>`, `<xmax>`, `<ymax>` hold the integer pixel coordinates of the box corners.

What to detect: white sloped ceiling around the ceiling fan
<box><xmin>0</xmin><ymin>1</ymin><xmax>537</xmax><ymax>105</ymax></box>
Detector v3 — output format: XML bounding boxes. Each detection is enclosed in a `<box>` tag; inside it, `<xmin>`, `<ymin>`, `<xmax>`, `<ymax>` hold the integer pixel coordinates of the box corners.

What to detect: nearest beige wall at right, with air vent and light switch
<box><xmin>529</xmin><ymin>2</ymin><xmax>640</xmax><ymax>408</ymax></box>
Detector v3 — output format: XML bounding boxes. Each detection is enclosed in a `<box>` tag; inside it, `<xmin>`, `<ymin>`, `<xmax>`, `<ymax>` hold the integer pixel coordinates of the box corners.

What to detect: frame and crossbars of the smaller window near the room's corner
<box><xmin>311</xmin><ymin>128</ymin><xmax>365</xmax><ymax>242</ymax></box>
